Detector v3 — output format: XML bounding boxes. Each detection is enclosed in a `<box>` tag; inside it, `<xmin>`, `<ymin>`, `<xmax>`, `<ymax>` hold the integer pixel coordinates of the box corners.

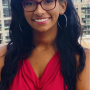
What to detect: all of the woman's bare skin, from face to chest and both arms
<box><xmin>0</xmin><ymin>0</ymin><xmax>90</xmax><ymax>90</ymax></box>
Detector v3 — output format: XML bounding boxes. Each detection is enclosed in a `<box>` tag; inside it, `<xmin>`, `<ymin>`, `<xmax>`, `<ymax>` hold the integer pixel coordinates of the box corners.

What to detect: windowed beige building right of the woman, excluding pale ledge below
<box><xmin>73</xmin><ymin>0</ymin><xmax>90</xmax><ymax>35</ymax></box>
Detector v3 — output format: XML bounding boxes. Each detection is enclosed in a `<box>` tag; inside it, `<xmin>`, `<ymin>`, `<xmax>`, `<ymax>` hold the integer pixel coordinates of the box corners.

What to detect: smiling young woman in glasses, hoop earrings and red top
<box><xmin>0</xmin><ymin>0</ymin><xmax>89</xmax><ymax>90</ymax></box>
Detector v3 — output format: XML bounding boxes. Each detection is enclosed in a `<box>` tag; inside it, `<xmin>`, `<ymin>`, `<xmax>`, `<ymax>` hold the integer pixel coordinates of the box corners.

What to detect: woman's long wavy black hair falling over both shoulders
<box><xmin>0</xmin><ymin>0</ymin><xmax>85</xmax><ymax>90</ymax></box>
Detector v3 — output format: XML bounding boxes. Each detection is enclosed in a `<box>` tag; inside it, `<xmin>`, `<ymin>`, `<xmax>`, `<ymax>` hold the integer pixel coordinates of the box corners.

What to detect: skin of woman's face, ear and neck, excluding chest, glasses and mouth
<box><xmin>24</xmin><ymin>0</ymin><xmax>66</xmax><ymax>46</ymax></box>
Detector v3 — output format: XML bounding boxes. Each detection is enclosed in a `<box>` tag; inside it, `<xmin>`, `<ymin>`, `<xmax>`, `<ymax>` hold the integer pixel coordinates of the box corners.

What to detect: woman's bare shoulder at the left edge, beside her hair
<box><xmin>0</xmin><ymin>45</ymin><xmax>7</xmax><ymax>79</ymax></box>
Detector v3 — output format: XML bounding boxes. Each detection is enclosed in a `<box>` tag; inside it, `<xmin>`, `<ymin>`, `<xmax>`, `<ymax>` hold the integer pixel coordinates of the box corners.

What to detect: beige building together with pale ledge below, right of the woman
<box><xmin>73</xmin><ymin>0</ymin><xmax>90</xmax><ymax>49</ymax></box>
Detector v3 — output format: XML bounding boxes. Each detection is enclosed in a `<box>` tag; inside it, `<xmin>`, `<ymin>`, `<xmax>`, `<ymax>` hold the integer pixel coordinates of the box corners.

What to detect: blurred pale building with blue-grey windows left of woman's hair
<box><xmin>0</xmin><ymin>0</ymin><xmax>11</xmax><ymax>44</ymax></box>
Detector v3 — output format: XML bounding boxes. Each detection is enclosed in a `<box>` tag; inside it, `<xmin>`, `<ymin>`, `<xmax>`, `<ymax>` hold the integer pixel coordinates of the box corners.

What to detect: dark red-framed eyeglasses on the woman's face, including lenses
<box><xmin>22</xmin><ymin>0</ymin><xmax>57</xmax><ymax>12</ymax></box>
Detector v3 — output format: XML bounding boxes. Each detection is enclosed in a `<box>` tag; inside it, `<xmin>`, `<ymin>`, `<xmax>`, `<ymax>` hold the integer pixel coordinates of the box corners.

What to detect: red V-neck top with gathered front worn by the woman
<box><xmin>9</xmin><ymin>51</ymin><xmax>68</xmax><ymax>90</ymax></box>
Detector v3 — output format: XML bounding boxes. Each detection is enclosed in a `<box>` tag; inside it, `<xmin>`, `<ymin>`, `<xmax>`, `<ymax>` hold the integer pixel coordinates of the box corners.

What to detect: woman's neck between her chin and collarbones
<box><xmin>33</xmin><ymin>26</ymin><xmax>57</xmax><ymax>47</ymax></box>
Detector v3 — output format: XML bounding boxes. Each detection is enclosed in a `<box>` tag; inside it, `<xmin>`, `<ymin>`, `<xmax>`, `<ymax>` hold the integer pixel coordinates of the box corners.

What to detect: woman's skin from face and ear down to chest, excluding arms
<box><xmin>24</xmin><ymin>0</ymin><xmax>67</xmax><ymax>78</ymax></box>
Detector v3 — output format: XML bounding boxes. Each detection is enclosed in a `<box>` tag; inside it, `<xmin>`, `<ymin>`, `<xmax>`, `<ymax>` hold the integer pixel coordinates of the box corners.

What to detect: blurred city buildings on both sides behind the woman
<box><xmin>0</xmin><ymin>0</ymin><xmax>90</xmax><ymax>48</ymax></box>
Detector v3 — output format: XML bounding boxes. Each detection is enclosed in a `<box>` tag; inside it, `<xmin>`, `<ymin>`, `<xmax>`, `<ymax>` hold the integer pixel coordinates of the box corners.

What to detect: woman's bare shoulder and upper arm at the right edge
<box><xmin>76</xmin><ymin>48</ymin><xmax>90</xmax><ymax>90</ymax></box>
